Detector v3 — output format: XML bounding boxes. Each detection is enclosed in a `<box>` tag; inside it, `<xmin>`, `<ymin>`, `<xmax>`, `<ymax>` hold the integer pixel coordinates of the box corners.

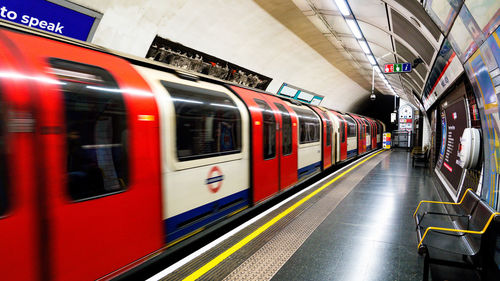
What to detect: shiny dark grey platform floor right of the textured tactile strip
<box><xmin>272</xmin><ymin>150</ymin><xmax>448</xmax><ymax>281</ymax></box>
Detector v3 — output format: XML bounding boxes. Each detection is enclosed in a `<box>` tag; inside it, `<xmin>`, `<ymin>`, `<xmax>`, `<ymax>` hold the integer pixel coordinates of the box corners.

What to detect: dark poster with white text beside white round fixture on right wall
<box><xmin>440</xmin><ymin>99</ymin><xmax>467</xmax><ymax>190</ymax></box>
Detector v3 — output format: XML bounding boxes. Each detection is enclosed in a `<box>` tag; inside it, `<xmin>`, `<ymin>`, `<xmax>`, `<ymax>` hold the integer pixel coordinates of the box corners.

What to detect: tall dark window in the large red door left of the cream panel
<box><xmin>49</xmin><ymin>58</ymin><xmax>128</xmax><ymax>201</ymax></box>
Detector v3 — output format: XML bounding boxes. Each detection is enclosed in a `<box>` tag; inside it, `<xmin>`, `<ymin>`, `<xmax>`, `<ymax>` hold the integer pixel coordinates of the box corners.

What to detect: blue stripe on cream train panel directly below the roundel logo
<box><xmin>164</xmin><ymin>189</ymin><xmax>249</xmax><ymax>243</ymax></box>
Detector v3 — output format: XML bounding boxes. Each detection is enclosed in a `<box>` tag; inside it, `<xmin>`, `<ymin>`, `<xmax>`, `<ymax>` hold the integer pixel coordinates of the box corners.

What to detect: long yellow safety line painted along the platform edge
<box><xmin>183</xmin><ymin>150</ymin><xmax>384</xmax><ymax>281</ymax></box>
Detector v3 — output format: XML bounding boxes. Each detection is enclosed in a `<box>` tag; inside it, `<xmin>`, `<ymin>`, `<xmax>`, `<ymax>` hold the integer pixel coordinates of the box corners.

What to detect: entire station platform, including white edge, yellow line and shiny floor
<box><xmin>148</xmin><ymin>150</ymin><xmax>473</xmax><ymax>281</ymax></box>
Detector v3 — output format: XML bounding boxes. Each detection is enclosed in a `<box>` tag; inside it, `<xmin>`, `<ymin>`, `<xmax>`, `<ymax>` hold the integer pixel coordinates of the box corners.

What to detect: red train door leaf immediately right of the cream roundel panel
<box><xmin>231</xmin><ymin>86</ymin><xmax>281</xmax><ymax>202</ymax></box>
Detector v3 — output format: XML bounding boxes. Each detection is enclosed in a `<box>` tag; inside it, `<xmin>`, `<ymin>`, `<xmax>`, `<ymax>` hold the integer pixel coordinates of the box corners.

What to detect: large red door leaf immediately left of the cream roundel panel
<box><xmin>9</xmin><ymin>33</ymin><xmax>164</xmax><ymax>281</ymax></box>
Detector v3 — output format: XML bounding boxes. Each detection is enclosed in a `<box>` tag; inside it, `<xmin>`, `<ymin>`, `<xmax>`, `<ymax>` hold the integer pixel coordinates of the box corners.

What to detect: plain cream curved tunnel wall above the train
<box><xmin>65</xmin><ymin>0</ymin><xmax>369</xmax><ymax>111</ymax></box>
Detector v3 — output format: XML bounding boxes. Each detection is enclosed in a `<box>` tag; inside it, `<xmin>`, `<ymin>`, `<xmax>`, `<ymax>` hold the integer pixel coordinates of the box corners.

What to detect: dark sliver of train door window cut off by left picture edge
<box><xmin>0</xmin><ymin>96</ymin><xmax>9</xmax><ymax>217</ymax></box>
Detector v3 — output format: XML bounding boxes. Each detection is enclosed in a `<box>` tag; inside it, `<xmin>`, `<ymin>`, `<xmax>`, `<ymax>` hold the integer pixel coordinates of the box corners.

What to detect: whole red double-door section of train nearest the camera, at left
<box><xmin>0</xmin><ymin>26</ymin><xmax>162</xmax><ymax>280</ymax></box>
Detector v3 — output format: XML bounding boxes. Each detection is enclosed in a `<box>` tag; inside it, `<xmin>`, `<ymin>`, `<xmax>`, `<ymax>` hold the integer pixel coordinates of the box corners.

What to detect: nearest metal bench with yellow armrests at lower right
<box><xmin>413</xmin><ymin>189</ymin><xmax>500</xmax><ymax>280</ymax></box>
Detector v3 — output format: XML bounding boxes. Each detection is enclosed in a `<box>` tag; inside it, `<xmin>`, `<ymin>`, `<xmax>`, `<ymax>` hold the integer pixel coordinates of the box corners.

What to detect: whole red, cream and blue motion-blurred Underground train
<box><xmin>0</xmin><ymin>26</ymin><xmax>384</xmax><ymax>280</ymax></box>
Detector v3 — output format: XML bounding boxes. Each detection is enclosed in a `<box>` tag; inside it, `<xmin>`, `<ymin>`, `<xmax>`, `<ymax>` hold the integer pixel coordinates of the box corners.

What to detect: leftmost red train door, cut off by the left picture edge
<box><xmin>0</xmin><ymin>35</ymin><xmax>39</xmax><ymax>281</ymax></box>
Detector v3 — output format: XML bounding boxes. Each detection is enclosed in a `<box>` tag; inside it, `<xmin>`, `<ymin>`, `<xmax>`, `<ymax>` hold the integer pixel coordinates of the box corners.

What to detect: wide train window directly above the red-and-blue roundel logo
<box><xmin>161</xmin><ymin>81</ymin><xmax>241</xmax><ymax>161</ymax></box>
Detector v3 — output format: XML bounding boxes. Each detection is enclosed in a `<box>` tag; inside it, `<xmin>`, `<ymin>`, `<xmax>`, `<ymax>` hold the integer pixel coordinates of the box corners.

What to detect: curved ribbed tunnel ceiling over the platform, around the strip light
<box><xmin>255</xmin><ymin>0</ymin><xmax>444</xmax><ymax>108</ymax></box>
